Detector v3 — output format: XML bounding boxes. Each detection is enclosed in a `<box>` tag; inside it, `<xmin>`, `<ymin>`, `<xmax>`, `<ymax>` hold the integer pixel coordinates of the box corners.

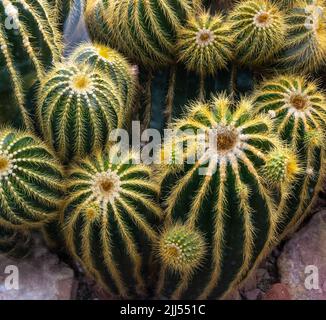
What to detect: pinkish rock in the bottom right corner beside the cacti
<box><xmin>278</xmin><ymin>210</ymin><xmax>326</xmax><ymax>300</ymax></box>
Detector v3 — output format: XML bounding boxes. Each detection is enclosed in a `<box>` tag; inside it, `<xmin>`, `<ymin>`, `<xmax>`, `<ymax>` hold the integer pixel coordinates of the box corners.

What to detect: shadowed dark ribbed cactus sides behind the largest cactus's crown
<box><xmin>140</xmin><ymin>64</ymin><xmax>254</xmax><ymax>131</ymax></box>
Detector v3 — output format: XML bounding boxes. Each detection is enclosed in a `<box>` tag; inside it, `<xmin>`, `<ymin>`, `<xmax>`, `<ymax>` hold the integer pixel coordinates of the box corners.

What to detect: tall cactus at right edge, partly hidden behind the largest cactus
<box><xmin>256</xmin><ymin>75</ymin><xmax>326</xmax><ymax>236</ymax></box>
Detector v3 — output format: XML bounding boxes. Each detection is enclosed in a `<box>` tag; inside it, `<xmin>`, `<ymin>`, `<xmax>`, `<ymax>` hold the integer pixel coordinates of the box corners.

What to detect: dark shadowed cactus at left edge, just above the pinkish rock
<box><xmin>0</xmin><ymin>226</ymin><xmax>31</xmax><ymax>258</ymax></box>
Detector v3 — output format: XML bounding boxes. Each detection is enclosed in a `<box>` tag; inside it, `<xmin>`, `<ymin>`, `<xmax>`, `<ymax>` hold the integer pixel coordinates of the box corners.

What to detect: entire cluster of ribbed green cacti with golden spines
<box><xmin>0</xmin><ymin>0</ymin><xmax>326</xmax><ymax>299</ymax></box>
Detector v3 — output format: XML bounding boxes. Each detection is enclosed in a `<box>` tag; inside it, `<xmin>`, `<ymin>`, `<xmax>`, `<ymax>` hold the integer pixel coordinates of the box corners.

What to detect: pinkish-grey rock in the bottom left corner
<box><xmin>0</xmin><ymin>240</ymin><xmax>77</xmax><ymax>300</ymax></box>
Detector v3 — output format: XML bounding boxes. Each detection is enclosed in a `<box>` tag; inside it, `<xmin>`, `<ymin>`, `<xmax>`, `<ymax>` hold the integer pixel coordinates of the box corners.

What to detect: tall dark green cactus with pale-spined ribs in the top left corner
<box><xmin>0</xmin><ymin>0</ymin><xmax>61</xmax><ymax>128</ymax></box>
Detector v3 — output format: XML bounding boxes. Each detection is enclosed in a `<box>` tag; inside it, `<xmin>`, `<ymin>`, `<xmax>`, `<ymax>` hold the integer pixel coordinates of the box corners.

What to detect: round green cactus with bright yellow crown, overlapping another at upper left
<box><xmin>38</xmin><ymin>63</ymin><xmax>125</xmax><ymax>161</ymax></box>
